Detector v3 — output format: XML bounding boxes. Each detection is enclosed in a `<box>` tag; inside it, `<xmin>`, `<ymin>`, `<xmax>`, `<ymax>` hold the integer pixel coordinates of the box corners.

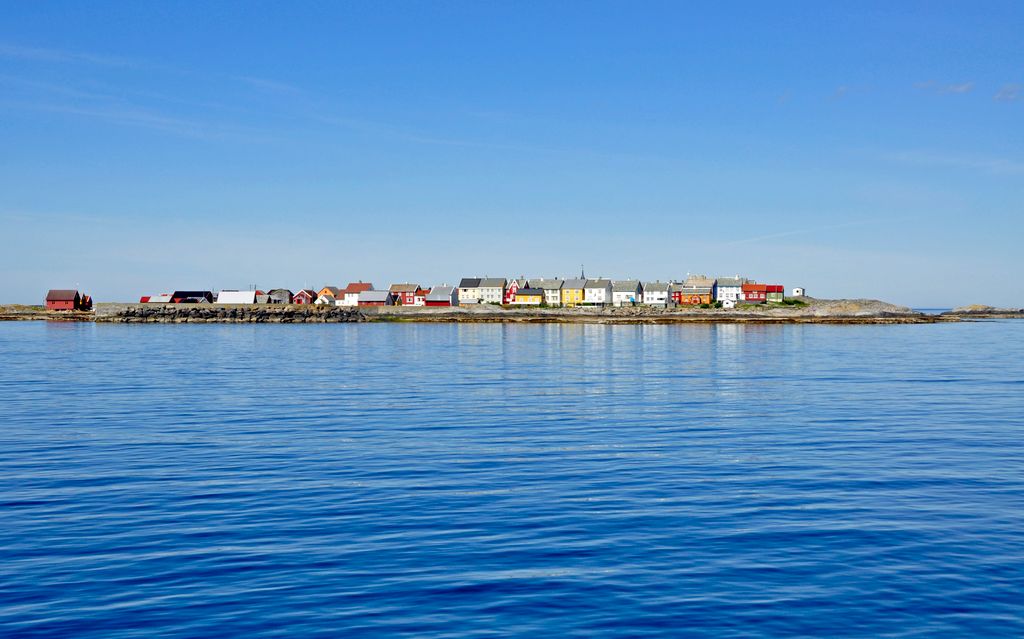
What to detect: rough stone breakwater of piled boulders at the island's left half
<box><xmin>96</xmin><ymin>304</ymin><xmax>367</xmax><ymax>324</ymax></box>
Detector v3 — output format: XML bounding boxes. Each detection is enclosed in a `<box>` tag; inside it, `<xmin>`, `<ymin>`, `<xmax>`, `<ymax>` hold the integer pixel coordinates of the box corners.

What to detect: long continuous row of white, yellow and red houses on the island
<box><xmin>139</xmin><ymin>275</ymin><xmax>805</xmax><ymax>308</ymax></box>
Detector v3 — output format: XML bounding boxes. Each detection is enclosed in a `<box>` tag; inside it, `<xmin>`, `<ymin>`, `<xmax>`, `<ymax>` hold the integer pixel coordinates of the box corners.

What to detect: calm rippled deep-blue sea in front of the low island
<box><xmin>0</xmin><ymin>321</ymin><xmax>1024</xmax><ymax>639</ymax></box>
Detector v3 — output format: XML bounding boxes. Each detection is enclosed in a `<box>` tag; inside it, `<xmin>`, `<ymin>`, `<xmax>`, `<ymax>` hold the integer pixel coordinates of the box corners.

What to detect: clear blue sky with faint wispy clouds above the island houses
<box><xmin>0</xmin><ymin>1</ymin><xmax>1024</xmax><ymax>306</ymax></box>
